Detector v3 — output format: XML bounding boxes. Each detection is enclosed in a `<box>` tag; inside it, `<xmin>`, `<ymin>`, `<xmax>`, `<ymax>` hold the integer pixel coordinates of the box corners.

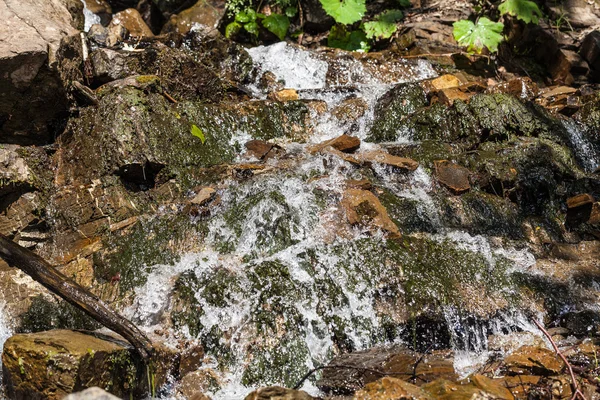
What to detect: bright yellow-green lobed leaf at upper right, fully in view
<box><xmin>453</xmin><ymin>17</ymin><xmax>504</xmax><ymax>53</ymax></box>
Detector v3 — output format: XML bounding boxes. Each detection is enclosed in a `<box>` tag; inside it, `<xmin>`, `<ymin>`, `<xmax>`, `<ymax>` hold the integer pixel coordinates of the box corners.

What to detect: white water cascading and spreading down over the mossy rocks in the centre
<box><xmin>119</xmin><ymin>43</ymin><xmax>576</xmax><ymax>399</ymax></box>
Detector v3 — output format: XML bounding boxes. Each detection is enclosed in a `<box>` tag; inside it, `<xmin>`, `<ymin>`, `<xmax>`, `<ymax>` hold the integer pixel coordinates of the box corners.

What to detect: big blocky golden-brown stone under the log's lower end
<box><xmin>2</xmin><ymin>330</ymin><xmax>146</xmax><ymax>400</ymax></box>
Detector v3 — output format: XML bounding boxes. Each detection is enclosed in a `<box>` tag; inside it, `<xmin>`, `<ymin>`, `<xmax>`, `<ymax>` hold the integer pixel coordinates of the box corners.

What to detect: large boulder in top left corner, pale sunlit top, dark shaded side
<box><xmin>0</xmin><ymin>0</ymin><xmax>77</xmax><ymax>144</ymax></box>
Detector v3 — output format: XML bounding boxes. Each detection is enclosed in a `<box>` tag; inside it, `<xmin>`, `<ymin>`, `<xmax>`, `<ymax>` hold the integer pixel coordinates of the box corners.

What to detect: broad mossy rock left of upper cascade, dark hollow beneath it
<box><xmin>61</xmin><ymin>86</ymin><xmax>308</xmax><ymax>183</ymax></box>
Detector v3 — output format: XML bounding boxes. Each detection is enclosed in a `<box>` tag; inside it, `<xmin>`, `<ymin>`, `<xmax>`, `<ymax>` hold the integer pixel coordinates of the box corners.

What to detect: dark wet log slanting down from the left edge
<box><xmin>0</xmin><ymin>235</ymin><xmax>153</xmax><ymax>362</ymax></box>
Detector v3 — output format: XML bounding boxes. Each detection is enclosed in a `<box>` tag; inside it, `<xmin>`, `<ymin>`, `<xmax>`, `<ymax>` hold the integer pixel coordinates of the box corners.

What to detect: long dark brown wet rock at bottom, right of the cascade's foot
<box><xmin>317</xmin><ymin>347</ymin><xmax>457</xmax><ymax>394</ymax></box>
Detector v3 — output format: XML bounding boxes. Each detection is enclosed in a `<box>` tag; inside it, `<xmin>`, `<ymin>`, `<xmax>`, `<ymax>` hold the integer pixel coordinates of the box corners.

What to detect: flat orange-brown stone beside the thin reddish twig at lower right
<box><xmin>504</xmin><ymin>346</ymin><xmax>564</xmax><ymax>376</ymax></box>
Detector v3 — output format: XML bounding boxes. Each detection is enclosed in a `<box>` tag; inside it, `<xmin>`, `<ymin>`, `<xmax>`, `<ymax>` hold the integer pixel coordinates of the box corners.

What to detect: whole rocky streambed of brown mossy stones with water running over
<box><xmin>0</xmin><ymin>0</ymin><xmax>600</xmax><ymax>400</ymax></box>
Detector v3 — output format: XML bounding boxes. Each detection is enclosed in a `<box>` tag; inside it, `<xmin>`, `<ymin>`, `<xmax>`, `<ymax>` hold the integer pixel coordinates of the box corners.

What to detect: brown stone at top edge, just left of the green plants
<box><xmin>161</xmin><ymin>0</ymin><xmax>225</xmax><ymax>35</ymax></box>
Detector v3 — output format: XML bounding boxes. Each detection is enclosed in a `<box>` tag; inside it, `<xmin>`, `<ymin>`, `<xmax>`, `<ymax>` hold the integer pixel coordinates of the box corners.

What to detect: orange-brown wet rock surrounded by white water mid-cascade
<box><xmin>341</xmin><ymin>189</ymin><xmax>401</xmax><ymax>238</ymax></box>
